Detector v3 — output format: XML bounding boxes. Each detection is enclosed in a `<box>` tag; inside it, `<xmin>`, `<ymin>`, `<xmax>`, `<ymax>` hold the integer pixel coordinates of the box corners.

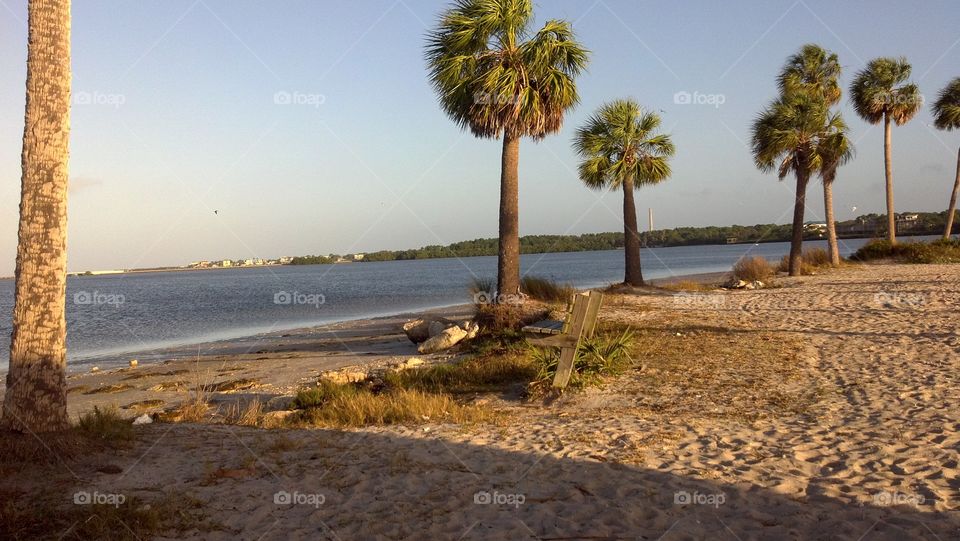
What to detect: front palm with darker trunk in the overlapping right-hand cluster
<box><xmin>751</xmin><ymin>92</ymin><xmax>830</xmax><ymax>276</ymax></box>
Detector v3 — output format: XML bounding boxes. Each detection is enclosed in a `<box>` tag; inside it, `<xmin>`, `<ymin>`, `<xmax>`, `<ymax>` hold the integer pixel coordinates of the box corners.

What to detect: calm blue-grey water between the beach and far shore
<box><xmin>0</xmin><ymin>239</ymin><xmax>884</xmax><ymax>371</ymax></box>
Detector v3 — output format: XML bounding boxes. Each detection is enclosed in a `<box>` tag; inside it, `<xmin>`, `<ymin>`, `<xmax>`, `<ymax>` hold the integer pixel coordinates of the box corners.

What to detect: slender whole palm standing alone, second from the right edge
<box><xmin>850</xmin><ymin>58</ymin><xmax>923</xmax><ymax>244</ymax></box>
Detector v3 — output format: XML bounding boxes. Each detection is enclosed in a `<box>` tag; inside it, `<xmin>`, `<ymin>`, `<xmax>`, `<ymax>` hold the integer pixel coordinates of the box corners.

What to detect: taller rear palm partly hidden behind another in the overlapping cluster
<box><xmin>778</xmin><ymin>43</ymin><xmax>853</xmax><ymax>265</ymax></box>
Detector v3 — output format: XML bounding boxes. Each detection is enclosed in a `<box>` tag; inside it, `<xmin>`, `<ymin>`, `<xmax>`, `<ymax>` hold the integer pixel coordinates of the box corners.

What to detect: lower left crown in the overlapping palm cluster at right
<box><xmin>751</xmin><ymin>92</ymin><xmax>831</xmax><ymax>180</ymax></box>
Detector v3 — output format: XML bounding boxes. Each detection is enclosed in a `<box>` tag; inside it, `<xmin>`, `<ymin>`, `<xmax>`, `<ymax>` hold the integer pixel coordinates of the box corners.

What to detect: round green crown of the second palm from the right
<box><xmin>850</xmin><ymin>58</ymin><xmax>923</xmax><ymax>126</ymax></box>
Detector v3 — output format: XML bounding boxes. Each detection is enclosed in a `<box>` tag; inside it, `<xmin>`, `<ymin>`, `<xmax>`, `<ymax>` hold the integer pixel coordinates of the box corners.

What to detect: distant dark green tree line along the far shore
<box><xmin>290</xmin><ymin>211</ymin><xmax>960</xmax><ymax>265</ymax></box>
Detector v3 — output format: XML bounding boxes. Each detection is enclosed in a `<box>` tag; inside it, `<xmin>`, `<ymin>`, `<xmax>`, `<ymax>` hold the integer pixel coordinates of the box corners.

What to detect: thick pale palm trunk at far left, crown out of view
<box><xmin>3</xmin><ymin>0</ymin><xmax>70</xmax><ymax>432</ymax></box>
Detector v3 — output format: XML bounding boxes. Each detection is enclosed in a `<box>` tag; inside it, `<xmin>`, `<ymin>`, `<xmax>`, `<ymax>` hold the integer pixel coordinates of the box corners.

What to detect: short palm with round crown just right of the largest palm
<box><xmin>573</xmin><ymin>100</ymin><xmax>674</xmax><ymax>286</ymax></box>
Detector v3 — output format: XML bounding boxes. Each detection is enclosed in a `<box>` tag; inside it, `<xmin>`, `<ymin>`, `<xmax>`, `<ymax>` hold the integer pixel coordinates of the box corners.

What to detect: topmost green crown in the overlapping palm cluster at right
<box><xmin>777</xmin><ymin>43</ymin><xmax>842</xmax><ymax>105</ymax></box>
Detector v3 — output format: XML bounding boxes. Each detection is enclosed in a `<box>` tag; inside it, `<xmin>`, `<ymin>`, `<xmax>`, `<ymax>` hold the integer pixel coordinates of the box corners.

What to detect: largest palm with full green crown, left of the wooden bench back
<box><xmin>426</xmin><ymin>0</ymin><xmax>588</xmax><ymax>295</ymax></box>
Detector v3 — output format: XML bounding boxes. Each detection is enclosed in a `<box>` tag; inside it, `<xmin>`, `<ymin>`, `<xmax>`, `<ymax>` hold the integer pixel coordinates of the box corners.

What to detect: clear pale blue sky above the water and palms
<box><xmin>0</xmin><ymin>0</ymin><xmax>960</xmax><ymax>276</ymax></box>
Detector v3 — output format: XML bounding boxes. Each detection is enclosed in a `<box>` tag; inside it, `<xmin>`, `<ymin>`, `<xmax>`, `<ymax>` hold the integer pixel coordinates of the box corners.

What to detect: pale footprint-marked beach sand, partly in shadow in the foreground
<box><xmin>5</xmin><ymin>265</ymin><xmax>960</xmax><ymax>540</ymax></box>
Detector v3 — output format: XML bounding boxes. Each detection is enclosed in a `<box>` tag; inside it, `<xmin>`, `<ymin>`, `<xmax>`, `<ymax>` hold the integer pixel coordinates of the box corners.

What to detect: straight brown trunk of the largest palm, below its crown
<box><xmin>497</xmin><ymin>135</ymin><xmax>520</xmax><ymax>299</ymax></box>
